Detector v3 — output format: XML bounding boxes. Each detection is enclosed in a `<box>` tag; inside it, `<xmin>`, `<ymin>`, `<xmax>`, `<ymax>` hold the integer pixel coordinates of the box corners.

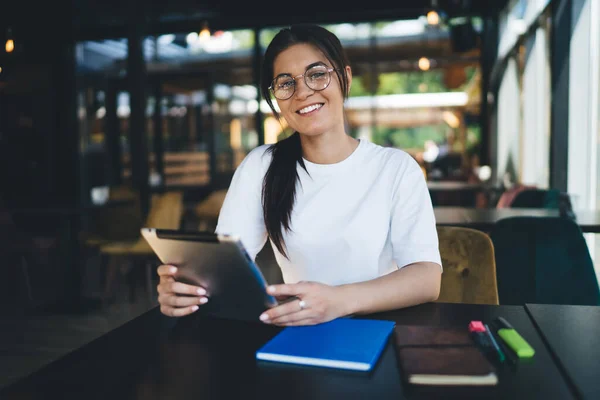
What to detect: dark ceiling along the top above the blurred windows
<box><xmin>0</xmin><ymin>0</ymin><xmax>507</xmax><ymax>40</ymax></box>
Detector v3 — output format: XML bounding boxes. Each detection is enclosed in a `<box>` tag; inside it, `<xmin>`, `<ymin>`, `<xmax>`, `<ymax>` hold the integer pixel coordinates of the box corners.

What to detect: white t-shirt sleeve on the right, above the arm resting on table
<box><xmin>390</xmin><ymin>155</ymin><xmax>442</xmax><ymax>268</ymax></box>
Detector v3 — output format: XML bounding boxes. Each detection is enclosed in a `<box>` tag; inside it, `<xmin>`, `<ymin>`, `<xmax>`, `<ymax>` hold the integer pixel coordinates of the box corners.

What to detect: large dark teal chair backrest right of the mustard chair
<box><xmin>490</xmin><ymin>217</ymin><xmax>600</xmax><ymax>305</ymax></box>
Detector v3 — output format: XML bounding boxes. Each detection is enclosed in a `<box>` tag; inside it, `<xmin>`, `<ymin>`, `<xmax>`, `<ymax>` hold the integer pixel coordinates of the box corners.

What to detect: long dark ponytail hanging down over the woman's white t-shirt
<box><xmin>262</xmin><ymin>132</ymin><xmax>306</xmax><ymax>258</ymax></box>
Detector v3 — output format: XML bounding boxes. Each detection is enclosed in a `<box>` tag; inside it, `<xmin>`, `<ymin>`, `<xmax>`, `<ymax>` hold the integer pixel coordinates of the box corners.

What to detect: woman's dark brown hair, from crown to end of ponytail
<box><xmin>260</xmin><ymin>24</ymin><xmax>350</xmax><ymax>257</ymax></box>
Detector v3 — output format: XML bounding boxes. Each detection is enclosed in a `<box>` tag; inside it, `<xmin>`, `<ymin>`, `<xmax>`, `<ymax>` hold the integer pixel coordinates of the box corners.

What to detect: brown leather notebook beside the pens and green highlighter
<box><xmin>394</xmin><ymin>325</ymin><xmax>498</xmax><ymax>386</ymax></box>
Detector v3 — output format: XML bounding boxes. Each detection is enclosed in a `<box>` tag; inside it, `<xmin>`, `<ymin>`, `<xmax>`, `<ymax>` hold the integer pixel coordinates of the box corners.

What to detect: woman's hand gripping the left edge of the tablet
<box><xmin>157</xmin><ymin>265</ymin><xmax>208</xmax><ymax>317</ymax></box>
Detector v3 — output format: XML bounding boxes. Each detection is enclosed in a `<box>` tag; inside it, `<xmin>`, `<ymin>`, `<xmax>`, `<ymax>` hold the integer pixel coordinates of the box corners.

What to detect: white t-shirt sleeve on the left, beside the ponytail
<box><xmin>216</xmin><ymin>146</ymin><xmax>268</xmax><ymax>260</ymax></box>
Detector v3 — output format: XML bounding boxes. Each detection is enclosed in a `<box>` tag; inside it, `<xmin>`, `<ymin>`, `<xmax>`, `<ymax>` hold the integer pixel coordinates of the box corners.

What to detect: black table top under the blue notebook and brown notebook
<box><xmin>0</xmin><ymin>303</ymin><xmax>573</xmax><ymax>400</ymax></box>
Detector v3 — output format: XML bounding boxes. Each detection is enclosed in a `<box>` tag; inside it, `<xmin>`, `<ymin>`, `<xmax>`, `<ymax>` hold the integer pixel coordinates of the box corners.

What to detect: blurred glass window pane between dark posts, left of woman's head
<box><xmin>145</xmin><ymin>29</ymin><xmax>258</xmax><ymax>187</ymax></box>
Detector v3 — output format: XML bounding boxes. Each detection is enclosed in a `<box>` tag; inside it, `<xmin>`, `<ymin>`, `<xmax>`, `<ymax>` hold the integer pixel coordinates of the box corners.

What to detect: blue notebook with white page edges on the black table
<box><xmin>256</xmin><ymin>318</ymin><xmax>395</xmax><ymax>371</ymax></box>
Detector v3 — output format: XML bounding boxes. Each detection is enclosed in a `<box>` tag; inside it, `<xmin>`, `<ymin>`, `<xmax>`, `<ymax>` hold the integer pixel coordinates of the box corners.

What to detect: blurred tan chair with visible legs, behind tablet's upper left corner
<box><xmin>100</xmin><ymin>191</ymin><xmax>184</xmax><ymax>299</ymax></box>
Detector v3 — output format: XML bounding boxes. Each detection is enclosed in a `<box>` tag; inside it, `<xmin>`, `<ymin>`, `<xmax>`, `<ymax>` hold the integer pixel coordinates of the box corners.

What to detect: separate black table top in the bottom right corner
<box><xmin>526</xmin><ymin>304</ymin><xmax>600</xmax><ymax>399</ymax></box>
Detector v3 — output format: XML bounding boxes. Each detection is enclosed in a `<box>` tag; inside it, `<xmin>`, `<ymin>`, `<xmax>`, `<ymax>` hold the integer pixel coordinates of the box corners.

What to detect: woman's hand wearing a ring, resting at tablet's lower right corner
<box><xmin>260</xmin><ymin>282</ymin><xmax>347</xmax><ymax>326</ymax></box>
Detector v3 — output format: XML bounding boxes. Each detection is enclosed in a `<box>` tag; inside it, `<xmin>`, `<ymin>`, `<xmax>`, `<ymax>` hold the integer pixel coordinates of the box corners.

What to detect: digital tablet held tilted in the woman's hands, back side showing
<box><xmin>141</xmin><ymin>228</ymin><xmax>277</xmax><ymax>322</ymax></box>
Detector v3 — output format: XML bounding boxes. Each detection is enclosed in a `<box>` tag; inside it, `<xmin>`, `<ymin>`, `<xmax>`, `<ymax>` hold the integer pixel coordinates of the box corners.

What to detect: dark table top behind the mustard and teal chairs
<box><xmin>433</xmin><ymin>206</ymin><xmax>600</xmax><ymax>233</ymax></box>
